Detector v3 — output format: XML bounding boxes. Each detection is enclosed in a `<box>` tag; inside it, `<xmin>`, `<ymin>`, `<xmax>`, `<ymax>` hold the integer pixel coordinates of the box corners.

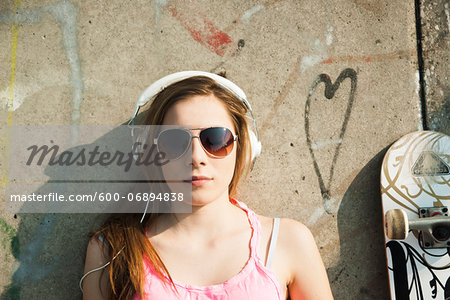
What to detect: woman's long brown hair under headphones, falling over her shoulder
<box><xmin>91</xmin><ymin>76</ymin><xmax>251</xmax><ymax>299</ymax></box>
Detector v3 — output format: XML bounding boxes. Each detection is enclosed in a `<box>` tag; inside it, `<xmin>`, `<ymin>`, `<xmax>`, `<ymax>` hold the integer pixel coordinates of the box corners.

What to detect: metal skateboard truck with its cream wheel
<box><xmin>385</xmin><ymin>206</ymin><xmax>450</xmax><ymax>249</ymax></box>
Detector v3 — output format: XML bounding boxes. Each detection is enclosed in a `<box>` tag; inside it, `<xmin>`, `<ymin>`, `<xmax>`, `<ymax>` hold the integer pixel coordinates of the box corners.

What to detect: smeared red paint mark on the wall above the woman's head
<box><xmin>168</xmin><ymin>5</ymin><xmax>233</xmax><ymax>56</ymax></box>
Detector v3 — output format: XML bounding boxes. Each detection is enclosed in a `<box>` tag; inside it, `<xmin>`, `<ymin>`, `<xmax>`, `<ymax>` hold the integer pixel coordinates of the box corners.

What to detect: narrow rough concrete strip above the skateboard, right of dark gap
<box><xmin>420</xmin><ymin>1</ymin><xmax>450</xmax><ymax>134</ymax></box>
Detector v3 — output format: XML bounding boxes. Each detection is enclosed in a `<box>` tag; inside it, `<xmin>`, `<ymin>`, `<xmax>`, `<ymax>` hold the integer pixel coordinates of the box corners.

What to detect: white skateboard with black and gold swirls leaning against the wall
<box><xmin>380</xmin><ymin>131</ymin><xmax>450</xmax><ymax>300</ymax></box>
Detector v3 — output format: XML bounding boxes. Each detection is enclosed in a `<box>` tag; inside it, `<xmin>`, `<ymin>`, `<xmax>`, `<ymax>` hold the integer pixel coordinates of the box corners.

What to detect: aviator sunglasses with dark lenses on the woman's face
<box><xmin>154</xmin><ymin>127</ymin><xmax>237</xmax><ymax>159</ymax></box>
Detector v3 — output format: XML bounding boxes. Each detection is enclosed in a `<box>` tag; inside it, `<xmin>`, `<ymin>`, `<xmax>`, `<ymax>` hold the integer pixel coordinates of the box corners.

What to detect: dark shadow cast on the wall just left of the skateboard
<box><xmin>327</xmin><ymin>146</ymin><xmax>390</xmax><ymax>300</ymax></box>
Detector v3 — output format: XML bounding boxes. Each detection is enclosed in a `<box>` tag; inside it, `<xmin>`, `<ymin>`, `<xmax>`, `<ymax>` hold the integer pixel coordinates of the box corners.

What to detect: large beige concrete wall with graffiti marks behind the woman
<box><xmin>0</xmin><ymin>0</ymin><xmax>448</xmax><ymax>299</ymax></box>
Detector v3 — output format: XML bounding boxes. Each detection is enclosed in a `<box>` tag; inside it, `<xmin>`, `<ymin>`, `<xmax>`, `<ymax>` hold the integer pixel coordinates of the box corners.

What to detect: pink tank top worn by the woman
<box><xmin>134</xmin><ymin>198</ymin><xmax>282</xmax><ymax>300</ymax></box>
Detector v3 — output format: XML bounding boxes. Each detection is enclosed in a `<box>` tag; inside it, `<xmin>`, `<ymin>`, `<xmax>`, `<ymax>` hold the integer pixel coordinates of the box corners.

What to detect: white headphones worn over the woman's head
<box><xmin>128</xmin><ymin>71</ymin><xmax>261</xmax><ymax>162</ymax></box>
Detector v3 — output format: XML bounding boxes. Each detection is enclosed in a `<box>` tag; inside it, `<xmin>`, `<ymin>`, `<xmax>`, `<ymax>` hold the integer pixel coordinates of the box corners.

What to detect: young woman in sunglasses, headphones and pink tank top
<box><xmin>83</xmin><ymin>73</ymin><xmax>332</xmax><ymax>300</ymax></box>
